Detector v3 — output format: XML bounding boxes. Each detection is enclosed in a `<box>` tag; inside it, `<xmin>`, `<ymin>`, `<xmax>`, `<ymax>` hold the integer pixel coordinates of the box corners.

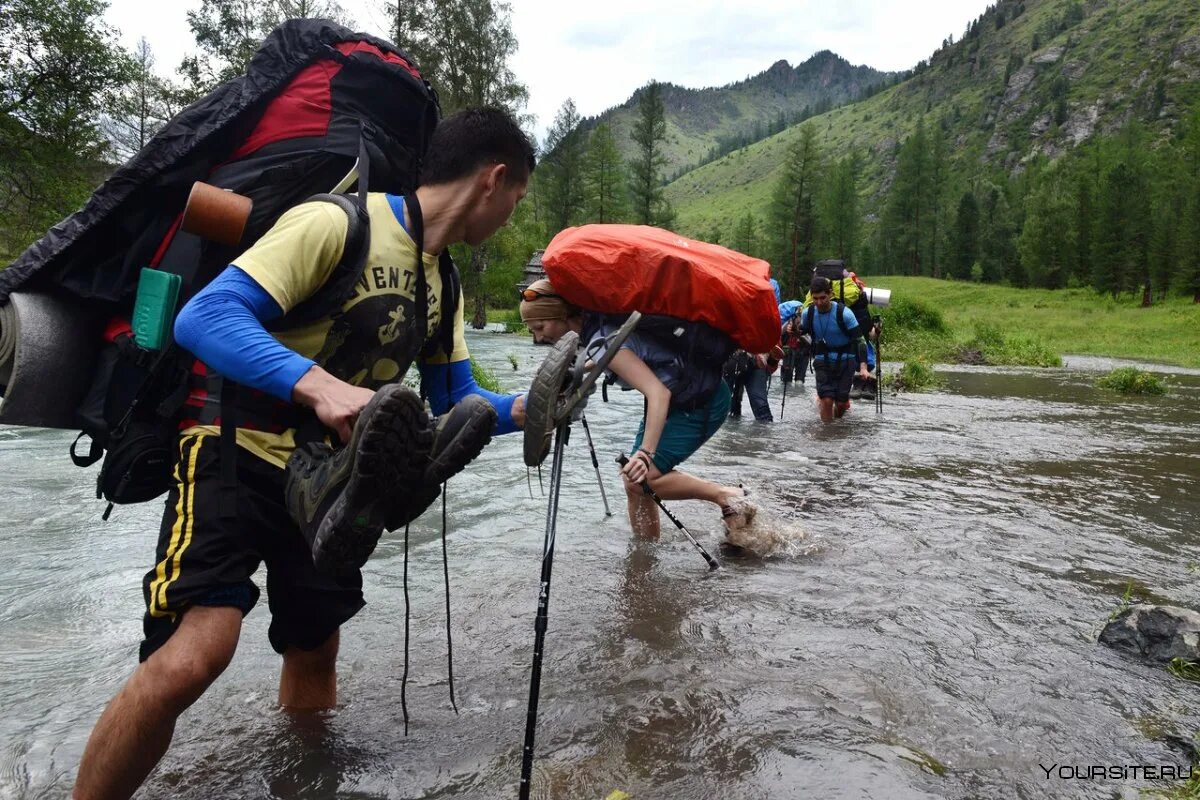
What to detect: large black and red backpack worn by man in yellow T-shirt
<box><xmin>0</xmin><ymin>19</ymin><xmax>446</xmax><ymax>520</ymax></box>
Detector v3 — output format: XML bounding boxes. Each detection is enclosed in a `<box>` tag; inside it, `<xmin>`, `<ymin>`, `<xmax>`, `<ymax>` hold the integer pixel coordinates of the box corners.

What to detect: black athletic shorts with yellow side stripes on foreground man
<box><xmin>139</xmin><ymin>434</ymin><xmax>366</xmax><ymax>661</ymax></box>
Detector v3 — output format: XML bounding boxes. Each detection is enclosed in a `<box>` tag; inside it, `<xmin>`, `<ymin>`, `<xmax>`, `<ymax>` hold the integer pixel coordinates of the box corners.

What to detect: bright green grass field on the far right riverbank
<box><xmin>864</xmin><ymin>276</ymin><xmax>1200</xmax><ymax>367</ymax></box>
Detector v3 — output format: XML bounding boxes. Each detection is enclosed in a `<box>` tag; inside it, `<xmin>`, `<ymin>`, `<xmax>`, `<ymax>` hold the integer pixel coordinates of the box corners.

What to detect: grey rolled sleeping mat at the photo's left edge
<box><xmin>0</xmin><ymin>291</ymin><xmax>103</xmax><ymax>429</ymax></box>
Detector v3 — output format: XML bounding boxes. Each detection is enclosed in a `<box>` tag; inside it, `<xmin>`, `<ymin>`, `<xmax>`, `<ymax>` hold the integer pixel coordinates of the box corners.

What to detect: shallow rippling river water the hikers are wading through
<box><xmin>0</xmin><ymin>335</ymin><xmax>1200</xmax><ymax>800</ymax></box>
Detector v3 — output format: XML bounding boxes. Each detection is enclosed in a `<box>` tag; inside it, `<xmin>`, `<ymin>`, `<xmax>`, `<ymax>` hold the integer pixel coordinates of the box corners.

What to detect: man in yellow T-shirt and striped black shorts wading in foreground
<box><xmin>74</xmin><ymin>109</ymin><xmax>534</xmax><ymax>800</ymax></box>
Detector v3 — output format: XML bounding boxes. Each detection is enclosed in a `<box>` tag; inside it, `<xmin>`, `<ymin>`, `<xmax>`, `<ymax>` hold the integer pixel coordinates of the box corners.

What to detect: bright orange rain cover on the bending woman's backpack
<box><xmin>541</xmin><ymin>224</ymin><xmax>780</xmax><ymax>353</ymax></box>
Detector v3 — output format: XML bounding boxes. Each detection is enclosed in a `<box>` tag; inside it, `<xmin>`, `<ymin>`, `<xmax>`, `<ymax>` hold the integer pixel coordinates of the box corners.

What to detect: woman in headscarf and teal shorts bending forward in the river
<box><xmin>521</xmin><ymin>279</ymin><xmax>749</xmax><ymax>539</ymax></box>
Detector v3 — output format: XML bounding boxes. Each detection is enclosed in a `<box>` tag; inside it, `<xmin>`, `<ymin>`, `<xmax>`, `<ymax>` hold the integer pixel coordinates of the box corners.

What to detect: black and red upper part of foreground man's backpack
<box><xmin>0</xmin><ymin>19</ymin><xmax>439</xmax><ymax>306</ymax></box>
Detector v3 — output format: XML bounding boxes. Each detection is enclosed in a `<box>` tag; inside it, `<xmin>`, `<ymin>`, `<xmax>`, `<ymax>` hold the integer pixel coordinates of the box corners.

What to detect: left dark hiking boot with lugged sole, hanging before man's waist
<box><xmin>283</xmin><ymin>384</ymin><xmax>437</xmax><ymax>573</ymax></box>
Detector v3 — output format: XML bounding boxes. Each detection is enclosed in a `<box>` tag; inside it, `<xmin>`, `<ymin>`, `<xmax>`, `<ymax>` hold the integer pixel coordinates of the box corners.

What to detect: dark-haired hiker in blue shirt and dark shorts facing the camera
<box><xmin>786</xmin><ymin>276</ymin><xmax>868</xmax><ymax>422</ymax></box>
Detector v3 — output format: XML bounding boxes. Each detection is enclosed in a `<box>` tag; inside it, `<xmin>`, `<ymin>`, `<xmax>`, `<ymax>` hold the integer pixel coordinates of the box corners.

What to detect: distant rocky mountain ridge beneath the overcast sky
<box><xmin>582</xmin><ymin>50</ymin><xmax>892</xmax><ymax>175</ymax></box>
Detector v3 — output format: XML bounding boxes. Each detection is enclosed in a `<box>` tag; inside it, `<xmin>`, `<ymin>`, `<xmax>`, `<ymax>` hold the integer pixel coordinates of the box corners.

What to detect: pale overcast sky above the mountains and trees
<box><xmin>107</xmin><ymin>0</ymin><xmax>992</xmax><ymax>138</ymax></box>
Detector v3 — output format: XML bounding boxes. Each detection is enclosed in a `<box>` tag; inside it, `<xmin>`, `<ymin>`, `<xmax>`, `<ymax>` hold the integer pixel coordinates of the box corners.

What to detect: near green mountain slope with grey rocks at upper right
<box><xmin>667</xmin><ymin>0</ymin><xmax>1200</xmax><ymax>235</ymax></box>
